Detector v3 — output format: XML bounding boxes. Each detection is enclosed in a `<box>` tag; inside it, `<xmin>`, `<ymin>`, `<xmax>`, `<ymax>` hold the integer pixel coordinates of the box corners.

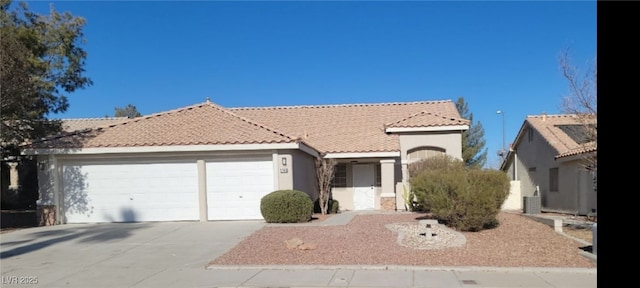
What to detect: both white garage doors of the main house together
<box><xmin>61</xmin><ymin>157</ymin><xmax>274</xmax><ymax>223</ymax></box>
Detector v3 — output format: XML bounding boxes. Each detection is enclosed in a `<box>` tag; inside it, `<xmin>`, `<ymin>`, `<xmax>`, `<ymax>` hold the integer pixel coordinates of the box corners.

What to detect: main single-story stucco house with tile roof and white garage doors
<box><xmin>24</xmin><ymin>100</ymin><xmax>469</xmax><ymax>223</ymax></box>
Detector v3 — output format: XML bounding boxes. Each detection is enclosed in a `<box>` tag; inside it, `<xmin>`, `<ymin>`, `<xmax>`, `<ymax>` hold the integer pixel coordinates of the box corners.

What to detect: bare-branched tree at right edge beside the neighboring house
<box><xmin>558</xmin><ymin>49</ymin><xmax>598</xmax><ymax>191</ymax></box>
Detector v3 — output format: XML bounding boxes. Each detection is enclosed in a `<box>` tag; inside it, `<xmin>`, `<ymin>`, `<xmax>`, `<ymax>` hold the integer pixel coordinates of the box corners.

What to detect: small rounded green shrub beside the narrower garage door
<box><xmin>260</xmin><ymin>190</ymin><xmax>313</xmax><ymax>223</ymax></box>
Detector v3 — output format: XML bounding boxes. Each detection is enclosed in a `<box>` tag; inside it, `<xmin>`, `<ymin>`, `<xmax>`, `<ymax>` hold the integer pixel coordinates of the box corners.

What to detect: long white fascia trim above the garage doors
<box><xmin>25</xmin><ymin>143</ymin><xmax>317</xmax><ymax>155</ymax></box>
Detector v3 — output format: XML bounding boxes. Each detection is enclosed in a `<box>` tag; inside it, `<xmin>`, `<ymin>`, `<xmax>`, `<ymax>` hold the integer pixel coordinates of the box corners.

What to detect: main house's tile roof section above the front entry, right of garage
<box><xmin>229</xmin><ymin>100</ymin><xmax>468</xmax><ymax>153</ymax></box>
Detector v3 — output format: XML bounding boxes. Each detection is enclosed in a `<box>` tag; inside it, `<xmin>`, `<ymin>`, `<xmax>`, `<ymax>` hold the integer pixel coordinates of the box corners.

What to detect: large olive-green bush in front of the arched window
<box><xmin>410</xmin><ymin>156</ymin><xmax>509</xmax><ymax>231</ymax></box>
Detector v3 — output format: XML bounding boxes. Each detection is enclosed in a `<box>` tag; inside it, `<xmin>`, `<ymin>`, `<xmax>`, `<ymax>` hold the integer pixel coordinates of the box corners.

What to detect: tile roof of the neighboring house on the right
<box><xmin>526</xmin><ymin>114</ymin><xmax>597</xmax><ymax>158</ymax></box>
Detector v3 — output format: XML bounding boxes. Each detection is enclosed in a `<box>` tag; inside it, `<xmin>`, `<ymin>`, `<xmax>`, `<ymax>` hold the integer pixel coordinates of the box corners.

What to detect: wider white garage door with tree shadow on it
<box><xmin>62</xmin><ymin>161</ymin><xmax>199</xmax><ymax>223</ymax></box>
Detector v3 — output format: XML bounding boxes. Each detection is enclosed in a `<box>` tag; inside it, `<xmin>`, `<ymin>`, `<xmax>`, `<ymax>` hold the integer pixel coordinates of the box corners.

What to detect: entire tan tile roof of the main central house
<box><xmin>27</xmin><ymin>101</ymin><xmax>469</xmax><ymax>153</ymax></box>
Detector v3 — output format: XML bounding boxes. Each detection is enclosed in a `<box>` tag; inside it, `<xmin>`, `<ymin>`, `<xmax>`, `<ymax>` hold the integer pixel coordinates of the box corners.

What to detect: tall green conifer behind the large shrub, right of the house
<box><xmin>456</xmin><ymin>97</ymin><xmax>487</xmax><ymax>168</ymax></box>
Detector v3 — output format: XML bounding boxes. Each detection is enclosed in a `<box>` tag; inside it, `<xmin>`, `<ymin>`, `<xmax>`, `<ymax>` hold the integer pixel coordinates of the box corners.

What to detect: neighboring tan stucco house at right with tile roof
<box><xmin>500</xmin><ymin>114</ymin><xmax>597</xmax><ymax>215</ymax></box>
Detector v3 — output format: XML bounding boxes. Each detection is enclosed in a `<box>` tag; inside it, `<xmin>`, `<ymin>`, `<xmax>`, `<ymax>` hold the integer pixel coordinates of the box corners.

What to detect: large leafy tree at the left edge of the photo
<box><xmin>0</xmin><ymin>0</ymin><xmax>93</xmax><ymax>159</ymax></box>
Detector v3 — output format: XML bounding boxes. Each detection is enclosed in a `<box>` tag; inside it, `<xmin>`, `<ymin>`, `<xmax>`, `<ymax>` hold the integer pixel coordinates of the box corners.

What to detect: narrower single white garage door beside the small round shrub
<box><xmin>207</xmin><ymin>158</ymin><xmax>274</xmax><ymax>220</ymax></box>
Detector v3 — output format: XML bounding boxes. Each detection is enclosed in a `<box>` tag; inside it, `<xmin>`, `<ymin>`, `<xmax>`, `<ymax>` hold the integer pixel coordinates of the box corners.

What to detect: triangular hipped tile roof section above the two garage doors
<box><xmin>33</xmin><ymin>102</ymin><xmax>297</xmax><ymax>148</ymax></box>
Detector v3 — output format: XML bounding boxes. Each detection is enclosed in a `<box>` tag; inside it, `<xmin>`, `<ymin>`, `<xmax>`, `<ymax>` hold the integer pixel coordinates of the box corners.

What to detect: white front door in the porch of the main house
<box><xmin>353</xmin><ymin>164</ymin><xmax>376</xmax><ymax>210</ymax></box>
